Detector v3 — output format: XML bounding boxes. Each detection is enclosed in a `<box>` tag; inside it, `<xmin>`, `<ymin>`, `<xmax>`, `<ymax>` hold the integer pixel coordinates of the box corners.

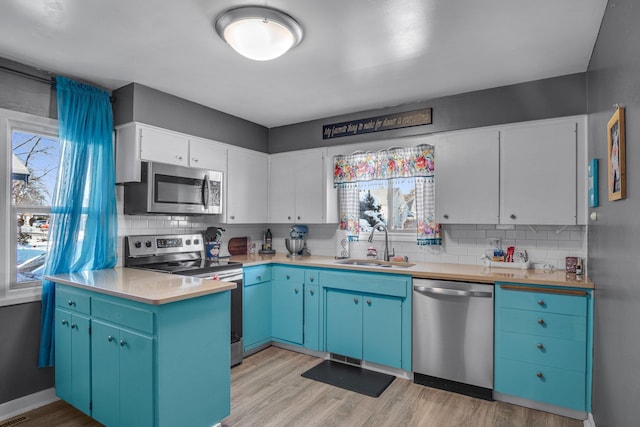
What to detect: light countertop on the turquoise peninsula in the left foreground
<box><xmin>45</xmin><ymin>267</ymin><xmax>236</xmax><ymax>305</ymax></box>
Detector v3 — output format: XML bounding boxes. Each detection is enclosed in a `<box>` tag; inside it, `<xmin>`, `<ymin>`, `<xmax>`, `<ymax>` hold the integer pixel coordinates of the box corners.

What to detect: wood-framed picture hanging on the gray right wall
<box><xmin>607</xmin><ymin>107</ymin><xmax>627</xmax><ymax>200</ymax></box>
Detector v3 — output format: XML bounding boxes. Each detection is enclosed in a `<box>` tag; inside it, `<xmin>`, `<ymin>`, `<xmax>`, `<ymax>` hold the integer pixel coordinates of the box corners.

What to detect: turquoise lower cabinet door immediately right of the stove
<box><xmin>242</xmin><ymin>282</ymin><xmax>271</xmax><ymax>351</ymax></box>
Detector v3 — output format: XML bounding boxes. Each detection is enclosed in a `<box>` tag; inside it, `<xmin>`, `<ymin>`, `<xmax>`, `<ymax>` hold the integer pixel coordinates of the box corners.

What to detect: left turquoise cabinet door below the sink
<box><xmin>325</xmin><ymin>289</ymin><xmax>362</xmax><ymax>359</ymax></box>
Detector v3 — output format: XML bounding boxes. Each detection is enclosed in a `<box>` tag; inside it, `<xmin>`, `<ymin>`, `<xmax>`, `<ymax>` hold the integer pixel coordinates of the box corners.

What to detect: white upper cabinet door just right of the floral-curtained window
<box><xmin>435</xmin><ymin>129</ymin><xmax>500</xmax><ymax>224</ymax></box>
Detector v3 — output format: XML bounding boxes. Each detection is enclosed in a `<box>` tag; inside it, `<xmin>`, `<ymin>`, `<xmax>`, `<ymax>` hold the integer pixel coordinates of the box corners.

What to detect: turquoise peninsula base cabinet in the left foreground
<box><xmin>50</xmin><ymin>269</ymin><xmax>231</xmax><ymax>427</ymax></box>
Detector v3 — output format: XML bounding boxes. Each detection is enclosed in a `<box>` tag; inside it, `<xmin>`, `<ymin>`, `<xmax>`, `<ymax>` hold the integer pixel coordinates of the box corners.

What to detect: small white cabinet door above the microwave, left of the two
<box><xmin>138</xmin><ymin>127</ymin><xmax>189</xmax><ymax>166</ymax></box>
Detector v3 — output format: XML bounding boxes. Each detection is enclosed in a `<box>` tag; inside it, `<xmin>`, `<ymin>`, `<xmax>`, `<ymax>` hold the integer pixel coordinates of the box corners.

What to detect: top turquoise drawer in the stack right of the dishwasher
<box><xmin>500</xmin><ymin>285</ymin><xmax>587</xmax><ymax>316</ymax></box>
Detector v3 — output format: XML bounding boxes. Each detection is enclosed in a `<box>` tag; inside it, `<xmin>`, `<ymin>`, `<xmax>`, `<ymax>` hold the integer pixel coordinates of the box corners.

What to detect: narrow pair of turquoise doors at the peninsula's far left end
<box><xmin>55</xmin><ymin>308</ymin><xmax>91</xmax><ymax>415</ymax></box>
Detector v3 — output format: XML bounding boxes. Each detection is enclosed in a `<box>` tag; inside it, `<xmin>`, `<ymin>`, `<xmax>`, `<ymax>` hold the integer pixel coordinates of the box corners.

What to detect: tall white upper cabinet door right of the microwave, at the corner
<box><xmin>226</xmin><ymin>148</ymin><xmax>269</xmax><ymax>224</ymax></box>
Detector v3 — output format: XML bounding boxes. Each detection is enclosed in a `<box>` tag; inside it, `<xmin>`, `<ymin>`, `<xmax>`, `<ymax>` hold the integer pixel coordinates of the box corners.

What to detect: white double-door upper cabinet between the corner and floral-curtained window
<box><xmin>269</xmin><ymin>148</ymin><xmax>326</xmax><ymax>224</ymax></box>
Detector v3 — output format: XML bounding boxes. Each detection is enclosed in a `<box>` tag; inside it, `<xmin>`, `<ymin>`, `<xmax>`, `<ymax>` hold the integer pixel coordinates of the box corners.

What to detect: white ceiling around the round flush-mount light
<box><xmin>0</xmin><ymin>0</ymin><xmax>607</xmax><ymax>127</ymax></box>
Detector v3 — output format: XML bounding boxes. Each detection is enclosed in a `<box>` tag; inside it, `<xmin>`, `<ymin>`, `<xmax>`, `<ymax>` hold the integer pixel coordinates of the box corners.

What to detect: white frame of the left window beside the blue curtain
<box><xmin>0</xmin><ymin>108</ymin><xmax>58</xmax><ymax>307</ymax></box>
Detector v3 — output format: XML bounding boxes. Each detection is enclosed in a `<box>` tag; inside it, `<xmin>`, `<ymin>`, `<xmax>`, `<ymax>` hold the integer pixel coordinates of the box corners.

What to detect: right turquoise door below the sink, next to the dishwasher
<box><xmin>362</xmin><ymin>295</ymin><xmax>402</xmax><ymax>369</ymax></box>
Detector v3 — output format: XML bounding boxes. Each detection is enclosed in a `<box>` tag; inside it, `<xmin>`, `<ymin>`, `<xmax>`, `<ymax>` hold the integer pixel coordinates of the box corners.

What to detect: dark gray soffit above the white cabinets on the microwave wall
<box><xmin>113</xmin><ymin>83</ymin><xmax>269</xmax><ymax>153</ymax></box>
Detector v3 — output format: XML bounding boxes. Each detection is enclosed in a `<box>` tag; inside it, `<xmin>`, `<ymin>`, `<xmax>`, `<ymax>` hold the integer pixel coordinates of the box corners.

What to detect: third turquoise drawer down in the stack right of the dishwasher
<box><xmin>496</xmin><ymin>332</ymin><xmax>587</xmax><ymax>372</ymax></box>
